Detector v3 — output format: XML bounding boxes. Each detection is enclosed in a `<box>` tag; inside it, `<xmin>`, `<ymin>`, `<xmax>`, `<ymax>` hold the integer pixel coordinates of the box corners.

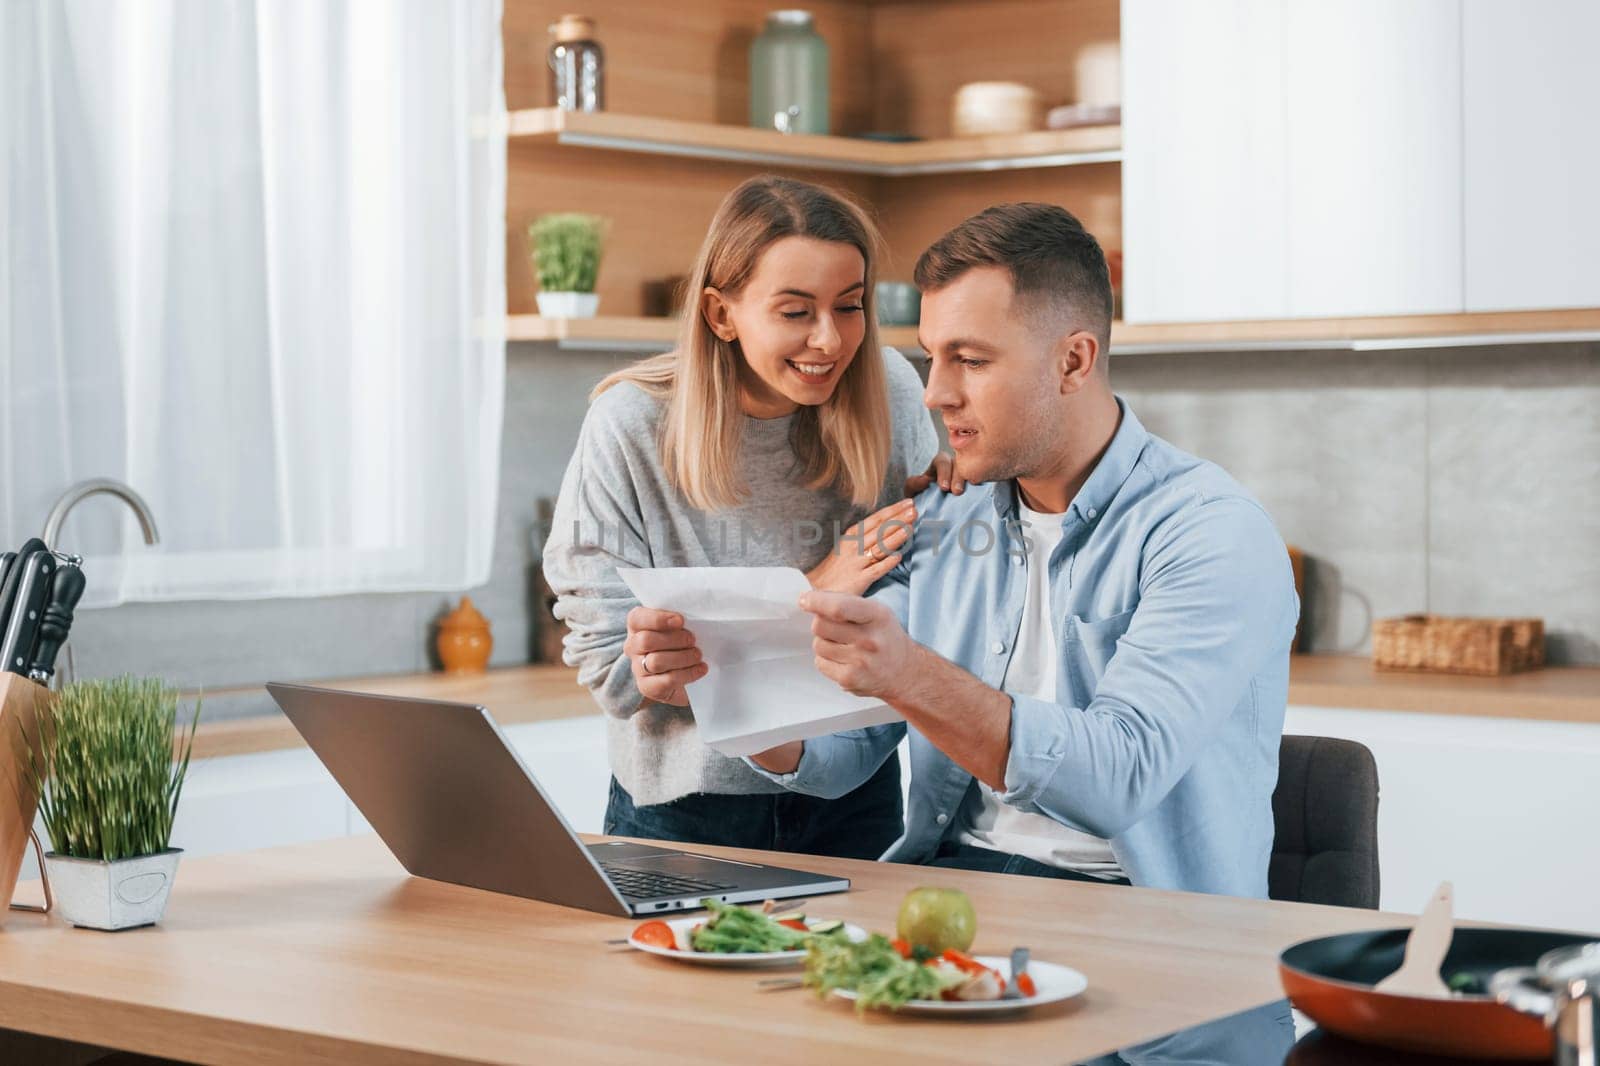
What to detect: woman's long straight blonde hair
<box><xmin>590</xmin><ymin>176</ymin><xmax>890</xmax><ymax>511</ymax></box>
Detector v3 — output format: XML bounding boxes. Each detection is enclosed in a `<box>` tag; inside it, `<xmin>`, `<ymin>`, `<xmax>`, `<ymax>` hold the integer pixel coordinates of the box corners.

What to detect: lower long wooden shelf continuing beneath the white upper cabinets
<box><xmin>506</xmin><ymin>309</ymin><xmax>1600</xmax><ymax>355</ymax></box>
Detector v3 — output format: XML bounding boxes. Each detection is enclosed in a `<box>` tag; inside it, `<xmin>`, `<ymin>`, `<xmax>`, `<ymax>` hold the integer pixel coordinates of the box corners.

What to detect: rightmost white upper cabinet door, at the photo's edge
<box><xmin>1462</xmin><ymin>0</ymin><xmax>1600</xmax><ymax>311</ymax></box>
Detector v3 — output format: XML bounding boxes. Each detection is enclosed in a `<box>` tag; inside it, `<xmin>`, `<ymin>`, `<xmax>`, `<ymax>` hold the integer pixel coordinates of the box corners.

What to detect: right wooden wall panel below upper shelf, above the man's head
<box><xmin>878</xmin><ymin>163</ymin><xmax>1122</xmax><ymax>280</ymax></box>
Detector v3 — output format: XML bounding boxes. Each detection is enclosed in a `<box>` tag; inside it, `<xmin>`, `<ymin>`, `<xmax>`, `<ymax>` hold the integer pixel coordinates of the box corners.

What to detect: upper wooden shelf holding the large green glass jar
<box><xmin>509</xmin><ymin>107</ymin><xmax>1122</xmax><ymax>178</ymax></box>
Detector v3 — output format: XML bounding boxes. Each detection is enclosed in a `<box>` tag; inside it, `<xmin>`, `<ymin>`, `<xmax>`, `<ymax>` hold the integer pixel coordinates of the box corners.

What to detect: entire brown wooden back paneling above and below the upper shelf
<box><xmin>502</xmin><ymin>0</ymin><xmax>1122</xmax><ymax>315</ymax></box>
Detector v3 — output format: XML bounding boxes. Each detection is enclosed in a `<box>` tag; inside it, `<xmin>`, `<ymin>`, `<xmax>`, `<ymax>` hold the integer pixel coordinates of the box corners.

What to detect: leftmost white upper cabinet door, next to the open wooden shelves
<box><xmin>1122</xmin><ymin>0</ymin><xmax>1290</xmax><ymax>322</ymax></box>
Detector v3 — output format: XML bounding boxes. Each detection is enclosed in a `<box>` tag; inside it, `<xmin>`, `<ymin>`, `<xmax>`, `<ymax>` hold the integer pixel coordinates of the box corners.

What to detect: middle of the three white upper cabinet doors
<box><xmin>1280</xmin><ymin>0</ymin><xmax>1465</xmax><ymax>317</ymax></box>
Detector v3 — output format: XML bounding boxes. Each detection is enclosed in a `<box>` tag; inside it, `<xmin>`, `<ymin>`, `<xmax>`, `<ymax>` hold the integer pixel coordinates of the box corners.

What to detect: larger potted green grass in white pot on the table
<box><xmin>29</xmin><ymin>677</ymin><xmax>200</xmax><ymax>930</ymax></box>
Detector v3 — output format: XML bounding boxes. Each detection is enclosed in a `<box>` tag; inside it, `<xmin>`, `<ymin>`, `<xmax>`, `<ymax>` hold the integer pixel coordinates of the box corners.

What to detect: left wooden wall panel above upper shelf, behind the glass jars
<box><xmin>501</xmin><ymin>0</ymin><xmax>874</xmax><ymax>133</ymax></box>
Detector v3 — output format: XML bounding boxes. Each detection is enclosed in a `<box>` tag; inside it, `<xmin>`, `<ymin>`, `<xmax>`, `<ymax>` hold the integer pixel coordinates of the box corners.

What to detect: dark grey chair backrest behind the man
<box><xmin>1267</xmin><ymin>736</ymin><xmax>1378</xmax><ymax>909</ymax></box>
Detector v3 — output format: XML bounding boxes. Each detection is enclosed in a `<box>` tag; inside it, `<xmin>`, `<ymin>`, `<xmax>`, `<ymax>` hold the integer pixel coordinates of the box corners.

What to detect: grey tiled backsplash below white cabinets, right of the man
<box><xmin>1112</xmin><ymin>344</ymin><xmax>1600</xmax><ymax>663</ymax></box>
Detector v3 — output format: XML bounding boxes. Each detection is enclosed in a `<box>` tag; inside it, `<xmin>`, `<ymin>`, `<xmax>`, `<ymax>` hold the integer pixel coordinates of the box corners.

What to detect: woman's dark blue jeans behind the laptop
<box><xmin>605</xmin><ymin>755</ymin><xmax>906</xmax><ymax>860</ymax></box>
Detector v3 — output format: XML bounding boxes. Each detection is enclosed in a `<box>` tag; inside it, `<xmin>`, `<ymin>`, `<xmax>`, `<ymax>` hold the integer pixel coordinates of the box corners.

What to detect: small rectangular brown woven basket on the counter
<box><xmin>1373</xmin><ymin>615</ymin><xmax>1544</xmax><ymax>677</ymax></box>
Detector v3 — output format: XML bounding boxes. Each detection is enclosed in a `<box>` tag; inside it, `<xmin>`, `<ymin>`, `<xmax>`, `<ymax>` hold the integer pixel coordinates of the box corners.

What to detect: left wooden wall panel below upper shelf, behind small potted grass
<box><xmin>506</xmin><ymin>141</ymin><xmax>878</xmax><ymax>315</ymax></box>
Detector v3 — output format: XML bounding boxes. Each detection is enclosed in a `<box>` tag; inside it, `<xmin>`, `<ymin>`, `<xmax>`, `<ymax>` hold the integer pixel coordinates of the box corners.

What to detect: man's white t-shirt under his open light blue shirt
<box><xmin>955</xmin><ymin>499</ymin><xmax>1125</xmax><ymax>879</ymax></box>
